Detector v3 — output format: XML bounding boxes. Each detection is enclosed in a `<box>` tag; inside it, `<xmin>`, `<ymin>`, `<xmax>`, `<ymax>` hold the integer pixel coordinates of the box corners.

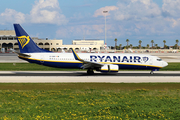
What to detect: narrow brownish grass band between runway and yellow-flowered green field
<box><xmin>0</xmin><ymin>83</ymin><xmax>180</xmax><ymax>90</ymax></box>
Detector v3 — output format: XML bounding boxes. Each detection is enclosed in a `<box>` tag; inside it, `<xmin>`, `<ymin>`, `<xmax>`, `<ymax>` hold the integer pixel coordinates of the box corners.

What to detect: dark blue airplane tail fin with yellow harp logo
<box><xmin>14</xmin><ymin>24</ymin><xmax>51</xmax><ymax>53</ymax></box>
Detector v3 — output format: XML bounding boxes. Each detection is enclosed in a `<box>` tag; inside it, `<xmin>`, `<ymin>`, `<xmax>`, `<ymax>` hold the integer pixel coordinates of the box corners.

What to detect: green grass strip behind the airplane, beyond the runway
<box><xmin>0</xmin><ymin>63</ymin><xmax>180</xmax><ymax>71</ymax></box>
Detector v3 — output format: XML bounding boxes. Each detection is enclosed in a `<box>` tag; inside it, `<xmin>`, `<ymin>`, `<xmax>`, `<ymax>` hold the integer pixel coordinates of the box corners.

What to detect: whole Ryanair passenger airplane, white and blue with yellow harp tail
<box><xmin>14</xmin><ymin>24</ymin><xmax>168</xmax><ymax>74</ymax></box>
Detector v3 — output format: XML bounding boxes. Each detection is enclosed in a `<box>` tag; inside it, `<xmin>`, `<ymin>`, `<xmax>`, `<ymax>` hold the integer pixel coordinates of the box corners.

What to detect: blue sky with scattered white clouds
<box><xmin>0</xmin><ymin>0</ymin><xmax>180</xmax><ymax>47</ymax></box>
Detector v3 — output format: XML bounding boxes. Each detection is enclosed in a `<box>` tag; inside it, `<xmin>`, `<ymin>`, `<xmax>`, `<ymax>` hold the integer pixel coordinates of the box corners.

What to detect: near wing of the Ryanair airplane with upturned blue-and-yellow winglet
<box><xmin>72</xmin><ymin>49</ymin><xmax>104</xmax><ymax>69</ymax></box>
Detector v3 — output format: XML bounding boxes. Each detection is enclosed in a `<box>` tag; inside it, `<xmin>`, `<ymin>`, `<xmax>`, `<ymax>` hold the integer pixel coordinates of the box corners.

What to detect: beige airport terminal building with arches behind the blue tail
<box><xmin>0</xmin><ymin>30</ymin><xmax>105</xmax><ymax>52</ymax></box>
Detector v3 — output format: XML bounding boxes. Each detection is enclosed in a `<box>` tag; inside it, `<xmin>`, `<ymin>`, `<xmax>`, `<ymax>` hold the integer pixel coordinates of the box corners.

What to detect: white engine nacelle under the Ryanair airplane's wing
<box><xmin>100</xmin><ymin>65</ymin><xmax>119</xmax><ymax>72</ymax></box>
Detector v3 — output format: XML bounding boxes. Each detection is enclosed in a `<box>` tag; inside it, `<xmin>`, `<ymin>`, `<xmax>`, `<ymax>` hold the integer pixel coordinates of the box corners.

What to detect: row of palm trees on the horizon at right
<box><xmin>114</xmin><ymin>38</ymin><xmax>179</xmax><ymax>50</ymax></box>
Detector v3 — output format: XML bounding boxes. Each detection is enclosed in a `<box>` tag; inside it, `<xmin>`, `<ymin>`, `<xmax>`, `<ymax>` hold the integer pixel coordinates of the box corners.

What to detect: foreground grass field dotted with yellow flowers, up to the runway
<box><xmin>0</xmin><ymin>83</ymin><xmax>180</xmax><ymax>120</ymax></box>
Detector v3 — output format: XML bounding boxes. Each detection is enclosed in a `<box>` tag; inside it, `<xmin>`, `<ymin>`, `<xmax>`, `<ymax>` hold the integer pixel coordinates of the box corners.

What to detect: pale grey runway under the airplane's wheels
<box><xmin>0</xmin><ymin>71</ymin><xmax>180</xmax><ymax>83</ymax></box>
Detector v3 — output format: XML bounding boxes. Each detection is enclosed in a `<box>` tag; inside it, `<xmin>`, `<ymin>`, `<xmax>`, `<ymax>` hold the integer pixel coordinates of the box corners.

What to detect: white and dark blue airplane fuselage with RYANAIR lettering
<box><xmin>19</xmin><ymin>53</ymin><xmax>167</xmax><ymax>70</ymax></box>
